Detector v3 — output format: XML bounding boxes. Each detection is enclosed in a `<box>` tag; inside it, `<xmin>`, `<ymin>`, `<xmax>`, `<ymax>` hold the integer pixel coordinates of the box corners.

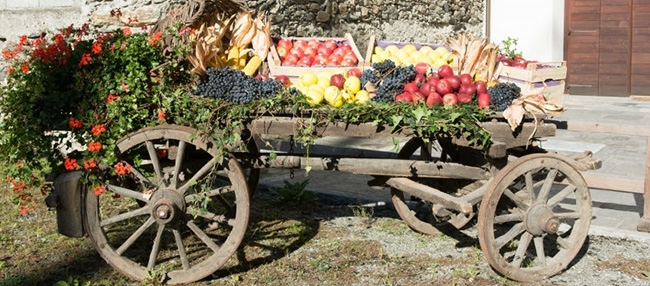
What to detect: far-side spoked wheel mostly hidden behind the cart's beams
<box><xmin>391</xmin><ymin>137</ymin><xmax>474</xmax><ymax>235</ymax></box>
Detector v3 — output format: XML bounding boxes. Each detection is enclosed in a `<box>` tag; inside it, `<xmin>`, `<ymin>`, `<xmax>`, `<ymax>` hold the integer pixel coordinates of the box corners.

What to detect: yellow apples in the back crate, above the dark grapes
<box><xmin>370</xmin><ymin>44</ymin><xmax>452</xmax><ymax>68</ymax></box>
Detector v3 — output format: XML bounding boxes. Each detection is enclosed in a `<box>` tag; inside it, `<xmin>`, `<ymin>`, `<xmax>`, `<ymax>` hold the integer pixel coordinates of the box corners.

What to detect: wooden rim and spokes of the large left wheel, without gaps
<box><xmin>84</xmin><ymin>125</ymin><xmax>250</xmax><ymax>284</ymax></box>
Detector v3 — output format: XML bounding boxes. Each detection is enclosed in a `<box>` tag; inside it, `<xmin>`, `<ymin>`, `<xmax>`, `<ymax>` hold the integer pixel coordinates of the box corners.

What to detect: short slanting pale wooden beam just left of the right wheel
<box><xmin>386</xmin><ymin>178</ymin><xmax>474</xmax><ymax>214</ymax></box>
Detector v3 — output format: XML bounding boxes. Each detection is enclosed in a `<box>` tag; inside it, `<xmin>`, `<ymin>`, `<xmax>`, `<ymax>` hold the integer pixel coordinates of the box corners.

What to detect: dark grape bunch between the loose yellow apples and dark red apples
<box><xmin>370</xmin><ymin>60</ymin><xmax>417</xmax><ymax>102</ymax></box>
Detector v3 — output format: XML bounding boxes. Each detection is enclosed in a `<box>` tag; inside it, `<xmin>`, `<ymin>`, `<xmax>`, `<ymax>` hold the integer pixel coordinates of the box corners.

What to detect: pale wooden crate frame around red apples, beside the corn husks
<box><xmin>267</xmin><ymin>33</ymin><xmax>365</xmax><ymax>81</ymax></box>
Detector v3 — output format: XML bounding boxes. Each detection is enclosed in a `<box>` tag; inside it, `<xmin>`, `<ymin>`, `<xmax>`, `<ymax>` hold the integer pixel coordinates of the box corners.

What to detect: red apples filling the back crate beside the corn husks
<box><xmin>275</xmin><ymin>38</ymin><xmax>359</xmax><ymax>67</ymax></box>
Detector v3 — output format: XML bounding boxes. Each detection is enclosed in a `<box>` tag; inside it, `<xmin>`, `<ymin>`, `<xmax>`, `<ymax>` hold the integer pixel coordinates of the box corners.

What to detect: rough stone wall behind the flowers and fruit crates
<box><xmin>0</xmin><ymin>0</ymin><xmax>485</xmax><ymax>78</ymax></box>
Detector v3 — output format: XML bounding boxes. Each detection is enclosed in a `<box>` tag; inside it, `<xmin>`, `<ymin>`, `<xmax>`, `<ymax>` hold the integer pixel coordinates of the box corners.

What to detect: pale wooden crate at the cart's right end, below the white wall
<box><xmin>497</xmin><ymin>61</ymin><xmax>567</xmax><ymax>82</ymax></box>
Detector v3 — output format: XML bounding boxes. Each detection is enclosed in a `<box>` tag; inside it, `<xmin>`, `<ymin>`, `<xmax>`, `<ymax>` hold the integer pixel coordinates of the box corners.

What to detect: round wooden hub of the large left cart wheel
<box><xmin>151</xmin><ymin>189</ymin><xmax>185</xmax><ymax>224</ymax></box>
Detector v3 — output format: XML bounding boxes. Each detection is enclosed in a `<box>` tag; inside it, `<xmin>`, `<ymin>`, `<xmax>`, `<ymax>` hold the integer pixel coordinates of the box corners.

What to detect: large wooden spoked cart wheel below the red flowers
<box><xmin>84</xmin><ymin>125</ymin><xmax>250</xmax><ymax>284</ymax></box>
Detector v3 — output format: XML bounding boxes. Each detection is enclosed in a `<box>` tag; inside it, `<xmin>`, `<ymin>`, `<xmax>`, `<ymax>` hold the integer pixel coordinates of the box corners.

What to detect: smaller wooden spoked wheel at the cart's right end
<box><xmin>478</xmin><ymin>154</ymin><xmax>591</xmax><ymax>282</ymax></box>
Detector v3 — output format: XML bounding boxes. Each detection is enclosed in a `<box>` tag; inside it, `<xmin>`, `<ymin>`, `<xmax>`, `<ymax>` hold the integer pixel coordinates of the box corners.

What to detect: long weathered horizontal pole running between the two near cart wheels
<box><xmin>240</xmin><ymin>154</ymin><xmax>490</xmax><ymax>180</ymax></box>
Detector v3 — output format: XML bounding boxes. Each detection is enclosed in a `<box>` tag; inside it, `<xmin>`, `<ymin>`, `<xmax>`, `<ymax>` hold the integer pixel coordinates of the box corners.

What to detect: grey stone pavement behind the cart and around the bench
<box><xmin>261</xmin><ymin>95</ymin><xmax>650</xmax><ymax>243</ymax></box>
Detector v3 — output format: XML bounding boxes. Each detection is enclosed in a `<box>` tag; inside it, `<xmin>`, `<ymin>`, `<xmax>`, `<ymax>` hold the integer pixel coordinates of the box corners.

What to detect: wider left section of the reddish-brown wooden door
<box><xmin>564</xmin><ymin>0</ymin><xmax>632</xmax><ymax>96</ymax></box>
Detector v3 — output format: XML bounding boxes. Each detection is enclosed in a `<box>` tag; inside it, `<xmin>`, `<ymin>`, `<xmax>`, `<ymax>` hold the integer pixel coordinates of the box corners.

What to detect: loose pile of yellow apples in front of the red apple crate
<box><xmin>293</xmin><ymin>68</ymin><xmax>370</xmax><ymax>108</ymax></box>
